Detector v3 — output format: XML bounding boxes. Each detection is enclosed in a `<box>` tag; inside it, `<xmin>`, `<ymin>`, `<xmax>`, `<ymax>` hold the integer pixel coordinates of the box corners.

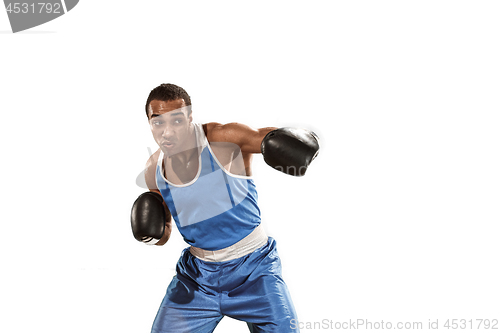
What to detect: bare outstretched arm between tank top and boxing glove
<box><xmin>208</xmin><ymin>123</ymin><xmax>276</xmax><ymax>154</ymax></box>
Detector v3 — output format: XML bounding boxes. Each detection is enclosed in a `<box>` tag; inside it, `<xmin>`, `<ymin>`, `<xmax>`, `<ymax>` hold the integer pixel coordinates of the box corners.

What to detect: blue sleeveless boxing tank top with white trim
<box><xmin>156</xmin><ymin>124</ymin><xmax>261</xmax><ymax>251</ymax></box>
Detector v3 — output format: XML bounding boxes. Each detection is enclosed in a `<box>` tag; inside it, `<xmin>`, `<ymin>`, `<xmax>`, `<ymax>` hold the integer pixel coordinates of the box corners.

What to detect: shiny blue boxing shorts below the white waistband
<box><xmin>151</xmin><ymin>237</ymin><xmax>299</xmax><ymax>333</ymax></box>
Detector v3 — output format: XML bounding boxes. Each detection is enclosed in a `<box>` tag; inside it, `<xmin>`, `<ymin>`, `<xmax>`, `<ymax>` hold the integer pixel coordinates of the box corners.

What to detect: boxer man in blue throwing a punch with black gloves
<box><xmin>131</xmin><ymin>84</ymin><xmax>319</xmax><ymax>333</ymax></box>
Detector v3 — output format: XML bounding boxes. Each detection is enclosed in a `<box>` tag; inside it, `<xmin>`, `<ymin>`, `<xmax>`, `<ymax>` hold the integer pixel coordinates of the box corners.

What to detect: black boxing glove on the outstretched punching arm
<box><xmin>260</xmin><ymin>127</ymin><xmax>319</xmax><ymax>176</ymax></box>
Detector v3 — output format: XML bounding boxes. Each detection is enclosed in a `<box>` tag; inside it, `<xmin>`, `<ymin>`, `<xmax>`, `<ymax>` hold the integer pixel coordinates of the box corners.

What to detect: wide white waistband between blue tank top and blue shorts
<box><xmin>189</xmin><ymin>224</ymin><xmax>267</xmax><ymax>262</ymax></box>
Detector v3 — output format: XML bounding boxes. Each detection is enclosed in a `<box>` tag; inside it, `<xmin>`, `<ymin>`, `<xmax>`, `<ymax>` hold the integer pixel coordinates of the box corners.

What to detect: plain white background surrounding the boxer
<box><xmin>0</xmin><ymin>0</ymin><xmax>500</xmax><ymax>333</ymax></box>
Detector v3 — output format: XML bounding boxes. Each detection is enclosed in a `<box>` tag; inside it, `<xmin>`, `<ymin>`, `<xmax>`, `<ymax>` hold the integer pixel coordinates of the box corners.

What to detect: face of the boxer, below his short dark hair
<box><xmin>148</xmin><ymin>98</ymin><xmax>193</xmax><ymax>155</ymax></box>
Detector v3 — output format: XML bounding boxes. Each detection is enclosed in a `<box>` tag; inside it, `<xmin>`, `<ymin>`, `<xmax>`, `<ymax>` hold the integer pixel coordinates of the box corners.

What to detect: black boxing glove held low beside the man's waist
<box><xmin>130</xmin><ymin>192</ymin><xmax>170</xmax><ymax>245</ymax></box>
